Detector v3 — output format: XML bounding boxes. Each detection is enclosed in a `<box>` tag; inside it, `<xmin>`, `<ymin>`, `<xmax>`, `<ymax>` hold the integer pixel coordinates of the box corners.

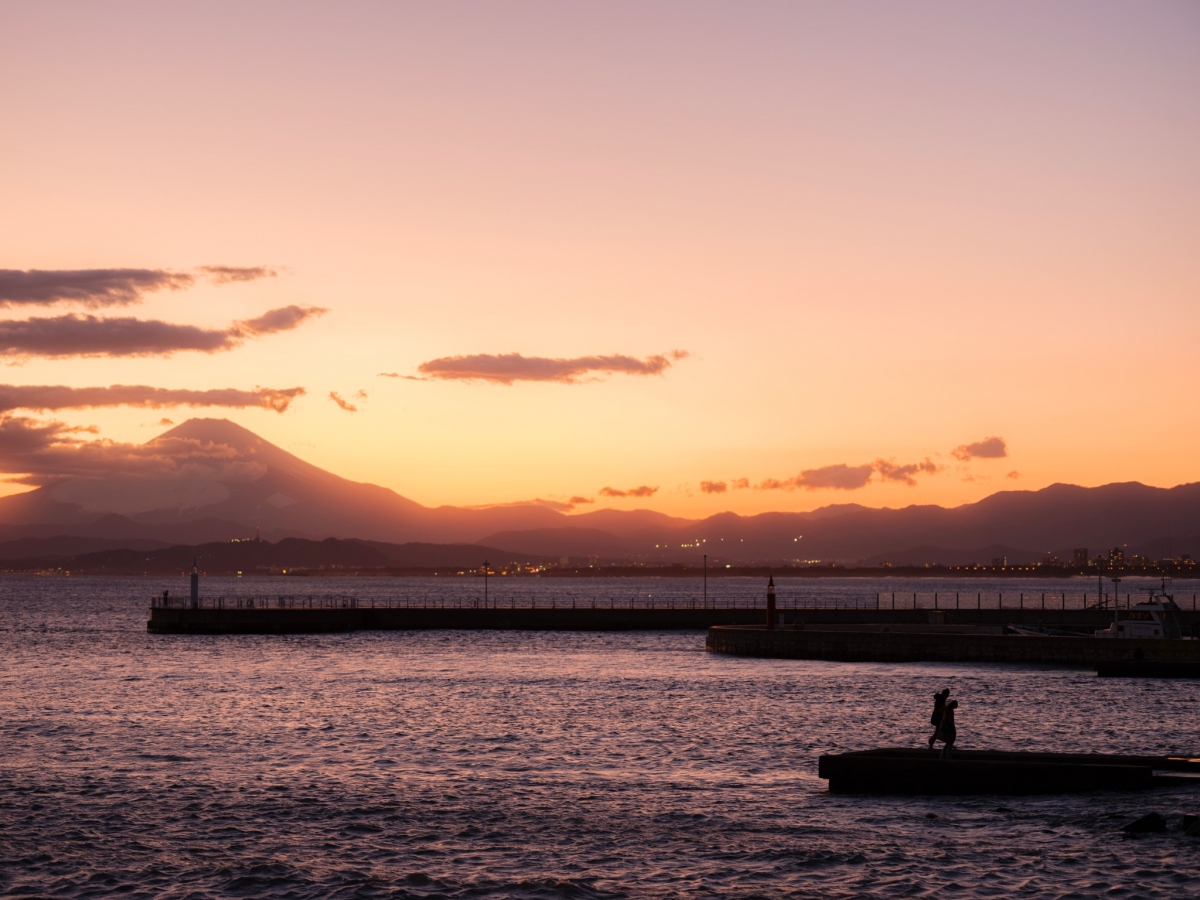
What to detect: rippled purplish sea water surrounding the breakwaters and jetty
<box><xmin>0</xmin><ymin>577</ymin><xmax>1200</xmax><ymax>898</ymax></box>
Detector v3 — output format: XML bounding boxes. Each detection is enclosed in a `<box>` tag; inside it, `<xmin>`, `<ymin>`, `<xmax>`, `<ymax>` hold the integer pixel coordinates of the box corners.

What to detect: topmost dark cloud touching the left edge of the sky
<box><xmin>0</xmin><ymin>269</ymin><xmax>196</xmax><ymax>307</ymax></box>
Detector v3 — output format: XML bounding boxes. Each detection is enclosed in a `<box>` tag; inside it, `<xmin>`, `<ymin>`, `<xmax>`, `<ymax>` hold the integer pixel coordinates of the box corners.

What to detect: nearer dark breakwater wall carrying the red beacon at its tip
<box><xmin>706</xmin><ymin>625</ymin><xmax>1200</xmax><ymax>666</ymax></box>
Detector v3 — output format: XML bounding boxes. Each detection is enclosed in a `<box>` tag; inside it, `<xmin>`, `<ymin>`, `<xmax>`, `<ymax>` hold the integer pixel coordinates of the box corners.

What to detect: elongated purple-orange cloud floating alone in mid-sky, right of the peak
<box><xmin>409</xmin><ymin>350</ymin><xmax>688</xmax><ymax>384</ymax></box>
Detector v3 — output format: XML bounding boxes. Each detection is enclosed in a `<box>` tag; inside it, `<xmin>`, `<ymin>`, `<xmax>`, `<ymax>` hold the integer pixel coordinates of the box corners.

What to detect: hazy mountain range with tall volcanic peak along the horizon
<box><xmin>0</xmin><ymin>419</ymin><xmax>1200</xmax><ymax>565</ymax></box>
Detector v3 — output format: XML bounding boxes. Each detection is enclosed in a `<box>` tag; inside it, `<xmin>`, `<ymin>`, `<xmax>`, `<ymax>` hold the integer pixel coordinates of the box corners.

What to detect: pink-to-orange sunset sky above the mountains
<box><xmin>0</xmin><ymin>0</ymin><xmax>1200</xmax><ymax>516</ymax></box>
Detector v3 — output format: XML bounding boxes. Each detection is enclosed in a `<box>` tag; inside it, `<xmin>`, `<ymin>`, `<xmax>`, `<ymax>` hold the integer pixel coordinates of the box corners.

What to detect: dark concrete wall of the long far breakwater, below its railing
<box><xmin>146</xmin><ymin>598</ymin><xmax>1200</xmax><ymax>638</ymax></box>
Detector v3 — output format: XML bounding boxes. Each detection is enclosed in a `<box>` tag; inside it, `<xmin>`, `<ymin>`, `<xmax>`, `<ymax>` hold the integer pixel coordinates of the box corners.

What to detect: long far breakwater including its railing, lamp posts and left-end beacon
<box><xmin>146</xmin><ymin>562</ymin><xmax>1200</xmax><ymax>638</ymax></box>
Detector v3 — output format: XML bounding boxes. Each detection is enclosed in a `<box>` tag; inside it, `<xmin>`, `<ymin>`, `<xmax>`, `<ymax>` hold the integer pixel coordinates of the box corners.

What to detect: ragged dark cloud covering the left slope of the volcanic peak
<box><xmin>0</xmin><ymin>415</ymin><xmax>254</xmax><ymax>485</ymax></box>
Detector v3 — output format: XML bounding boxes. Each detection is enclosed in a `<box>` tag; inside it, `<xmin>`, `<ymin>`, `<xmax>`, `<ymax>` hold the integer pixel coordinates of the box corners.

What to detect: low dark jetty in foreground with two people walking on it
<box><xmin>817</xmin><ymin>748</ymin><xmax>1200</xmax><ymax>796</ymax></box>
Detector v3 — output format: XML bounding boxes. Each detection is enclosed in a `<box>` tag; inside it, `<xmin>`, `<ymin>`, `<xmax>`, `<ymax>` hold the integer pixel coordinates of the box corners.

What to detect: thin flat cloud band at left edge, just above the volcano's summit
<box><xmin>0</xmin><ymin>384</ymin><xmax>305</xmax><ymax>413</ymax></box>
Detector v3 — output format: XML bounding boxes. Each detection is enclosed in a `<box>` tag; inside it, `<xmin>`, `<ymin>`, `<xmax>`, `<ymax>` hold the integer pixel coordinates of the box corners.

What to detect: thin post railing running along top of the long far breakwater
<box><xmin>150</xmin><ymin>592</ymin><xmax>1198</xmax><ymax>612</ymax></box>
